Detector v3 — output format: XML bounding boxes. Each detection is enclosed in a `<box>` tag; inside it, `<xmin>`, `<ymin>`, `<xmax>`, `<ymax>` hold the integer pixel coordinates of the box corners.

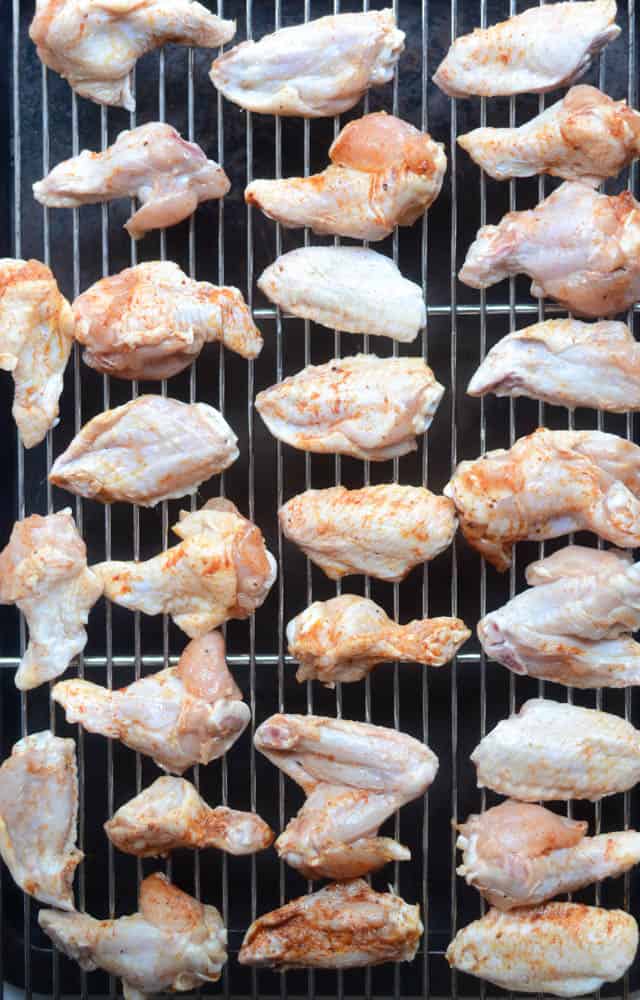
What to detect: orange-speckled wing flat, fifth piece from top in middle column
<box><xmin>278</xmin><ymin>483</ymin><xmax>457</xmax><ymax>581</ymax></box>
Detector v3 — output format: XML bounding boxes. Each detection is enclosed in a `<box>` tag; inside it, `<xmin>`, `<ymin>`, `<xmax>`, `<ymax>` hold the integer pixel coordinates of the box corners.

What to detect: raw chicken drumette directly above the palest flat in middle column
<box><xmin>244</xmin><ymin>111</ymin><xmax>447</xmax><ymax>240</ymax></box>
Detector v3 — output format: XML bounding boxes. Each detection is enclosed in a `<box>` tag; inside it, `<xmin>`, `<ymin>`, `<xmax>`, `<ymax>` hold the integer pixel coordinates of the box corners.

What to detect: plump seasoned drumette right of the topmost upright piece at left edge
<box><xmin>73</xmin><ymin>260</ymin><xmax>262</xmax><ymax>380</ymax></box>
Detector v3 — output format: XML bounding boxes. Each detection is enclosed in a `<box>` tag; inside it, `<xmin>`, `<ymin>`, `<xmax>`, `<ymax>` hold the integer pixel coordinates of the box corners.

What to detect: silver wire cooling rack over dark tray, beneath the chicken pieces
<box><xmin>0</xmin><ymin>0</ymin><xmax>640</xmax><ymax>998</ymax></box>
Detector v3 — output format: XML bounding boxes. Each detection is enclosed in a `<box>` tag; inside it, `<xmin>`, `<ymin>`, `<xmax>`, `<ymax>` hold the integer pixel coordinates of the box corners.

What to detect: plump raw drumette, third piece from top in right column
<box><xmin>458</xmin><ymin>181</ymin><xmax>640</xmax><ymax>318</ymax></box>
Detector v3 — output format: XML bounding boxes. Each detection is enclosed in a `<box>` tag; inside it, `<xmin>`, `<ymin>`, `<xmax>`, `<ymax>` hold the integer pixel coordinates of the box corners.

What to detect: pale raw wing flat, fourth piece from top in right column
<box><xmin>467</xmin><ymin>319</ymin><xmax>640</xmax><ymax>413</ymax></box>
